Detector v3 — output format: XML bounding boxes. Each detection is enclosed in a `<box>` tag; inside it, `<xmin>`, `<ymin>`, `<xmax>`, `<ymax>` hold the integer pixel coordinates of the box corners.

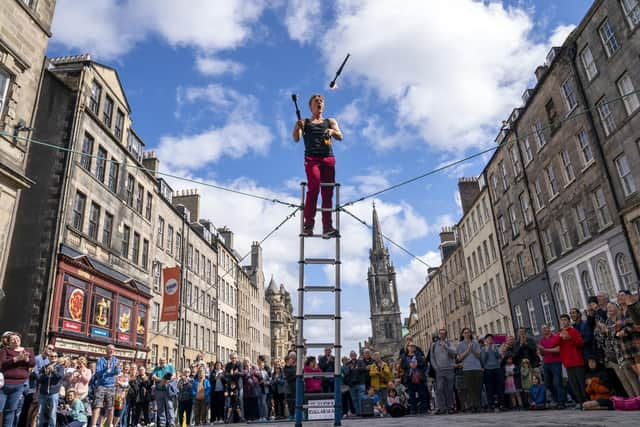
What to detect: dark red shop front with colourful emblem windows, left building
<box><xmin>49</xmin><ymin>246</ymin><xmax>151</xmax><ymax>363</ymax></box>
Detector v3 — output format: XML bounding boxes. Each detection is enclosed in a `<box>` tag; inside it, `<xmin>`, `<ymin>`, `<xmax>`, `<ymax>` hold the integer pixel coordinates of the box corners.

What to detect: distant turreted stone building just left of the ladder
<box><xmin>265</xmin><ymin>277</ymin><xmax>296</xmax><ymax>360</ymax></box>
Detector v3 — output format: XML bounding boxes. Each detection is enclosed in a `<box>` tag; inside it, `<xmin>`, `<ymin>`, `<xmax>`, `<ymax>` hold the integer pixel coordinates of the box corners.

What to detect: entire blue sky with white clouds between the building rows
<box><xmin>48</xmin><ymin>0</ymin><xmax>591</xmax><ymax>350</ymax></box>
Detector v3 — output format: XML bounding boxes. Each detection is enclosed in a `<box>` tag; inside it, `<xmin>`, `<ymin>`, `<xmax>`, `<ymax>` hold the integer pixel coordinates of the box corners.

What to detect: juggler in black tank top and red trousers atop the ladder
<box><xmin>293</xmin><ymin>94</ymin><xmax>342</xmax><ymax>239</ymax></box>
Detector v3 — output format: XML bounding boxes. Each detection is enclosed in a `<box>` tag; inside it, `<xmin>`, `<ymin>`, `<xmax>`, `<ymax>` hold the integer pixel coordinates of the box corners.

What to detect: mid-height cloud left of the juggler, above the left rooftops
<box><xmin>156</xmin><ymin>84</ymin><xmax>273</xmax><ymax>170</ymax></box>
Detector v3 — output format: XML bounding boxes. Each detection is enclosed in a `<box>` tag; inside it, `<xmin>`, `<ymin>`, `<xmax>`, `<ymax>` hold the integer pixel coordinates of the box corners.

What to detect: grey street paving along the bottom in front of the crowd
<box><xmin>238</xmin><ymin>409</ymin><xmax>640</xmax><ymax>427</ymax></box>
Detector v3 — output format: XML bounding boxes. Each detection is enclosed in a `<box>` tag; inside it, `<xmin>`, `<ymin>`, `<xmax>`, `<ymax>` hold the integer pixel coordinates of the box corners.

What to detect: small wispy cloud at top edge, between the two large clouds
<box><xmin>284</xmin><ymin>0</ymin><xmax>324</xmax><ymax>43</ymax></box>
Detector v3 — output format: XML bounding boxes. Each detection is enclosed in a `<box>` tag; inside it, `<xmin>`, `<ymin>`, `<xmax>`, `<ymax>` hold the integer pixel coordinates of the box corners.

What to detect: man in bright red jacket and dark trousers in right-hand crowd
<box><xmin>554</xmin><ymin>314</ymin><xmax>588</xmax><ymax>409</ymax></box>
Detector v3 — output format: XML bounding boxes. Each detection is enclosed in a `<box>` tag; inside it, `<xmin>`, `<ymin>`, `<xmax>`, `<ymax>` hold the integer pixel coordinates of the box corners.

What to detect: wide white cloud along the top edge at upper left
<box><xmin>52</xmin><ymin>0</ymin><xmax>266</xmax><ymax>59</ymax></box>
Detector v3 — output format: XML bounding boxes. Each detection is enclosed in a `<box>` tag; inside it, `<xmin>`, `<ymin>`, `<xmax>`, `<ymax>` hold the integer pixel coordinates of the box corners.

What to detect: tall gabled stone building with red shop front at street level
<box><xmin>3</xmin><ymin>55</ymin><xmax>155</xmax><ymax>360</ymax></box>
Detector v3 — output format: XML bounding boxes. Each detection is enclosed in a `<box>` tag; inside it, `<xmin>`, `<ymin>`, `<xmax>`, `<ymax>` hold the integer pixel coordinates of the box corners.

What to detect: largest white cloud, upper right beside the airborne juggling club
<box><xmin>318</xmin><ymin>0</ymin><xmax>566</xmax><ymax>151</ymax></box>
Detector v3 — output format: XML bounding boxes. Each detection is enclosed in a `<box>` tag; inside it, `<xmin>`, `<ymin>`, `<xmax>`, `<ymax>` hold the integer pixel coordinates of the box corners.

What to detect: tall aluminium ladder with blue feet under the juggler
<box><xmin>295</xmin><ymin>182</ymin><xmax>342</xmax><ymax>427</ymax></box>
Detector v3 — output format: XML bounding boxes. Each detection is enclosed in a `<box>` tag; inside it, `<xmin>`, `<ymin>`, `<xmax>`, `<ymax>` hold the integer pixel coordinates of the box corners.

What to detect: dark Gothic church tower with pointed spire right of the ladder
<box><xmin>367</xmin><ymin>205</ymin><xmax>402</xmax><ymax>359</ymax></box>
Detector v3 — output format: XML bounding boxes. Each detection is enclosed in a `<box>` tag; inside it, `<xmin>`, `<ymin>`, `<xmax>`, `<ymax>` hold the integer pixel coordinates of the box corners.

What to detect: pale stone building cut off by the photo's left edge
<box><xmin>0</xmin><ymin>0</ymin><xmax>56</xmax><ymax>300</ymax></box>
